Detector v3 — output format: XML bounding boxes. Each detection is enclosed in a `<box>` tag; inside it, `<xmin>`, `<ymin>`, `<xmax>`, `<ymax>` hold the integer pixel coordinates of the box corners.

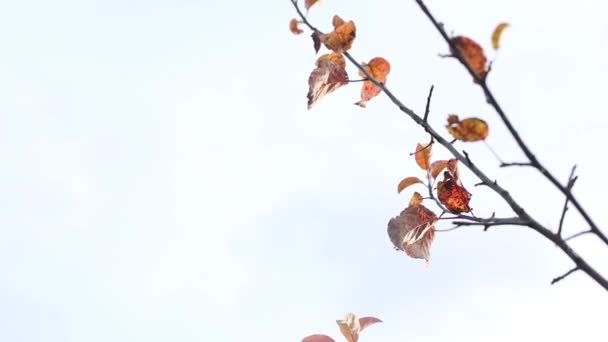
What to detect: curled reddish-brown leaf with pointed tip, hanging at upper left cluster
<box><xmin>307</xmin><ymin>60</ymin><xmax>348</xmax><ymax>109</ymax></box>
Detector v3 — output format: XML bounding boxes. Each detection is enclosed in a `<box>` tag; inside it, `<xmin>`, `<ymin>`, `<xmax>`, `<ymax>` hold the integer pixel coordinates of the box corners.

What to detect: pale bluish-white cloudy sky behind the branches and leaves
<box><xmin>0</xmin><ymin>0</ymin><xmax>608</xmax><ymax>342</ymax></box>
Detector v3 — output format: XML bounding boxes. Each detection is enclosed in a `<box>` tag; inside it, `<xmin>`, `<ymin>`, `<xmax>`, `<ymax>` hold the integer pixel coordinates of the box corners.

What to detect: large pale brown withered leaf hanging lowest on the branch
<box><xmin>388</xmin><ymin>205</ymin><xmax>437</xmax><ymax>262</ymax></box>
